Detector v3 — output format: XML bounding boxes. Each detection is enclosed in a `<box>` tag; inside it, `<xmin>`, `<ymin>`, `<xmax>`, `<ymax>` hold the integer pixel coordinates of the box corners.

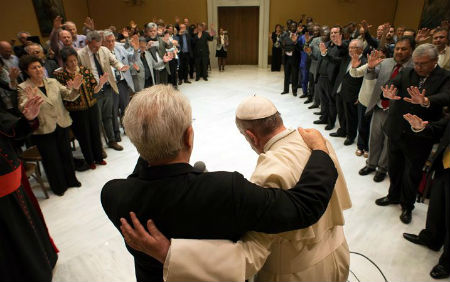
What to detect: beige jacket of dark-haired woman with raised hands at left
<box><xmin>18</xmin><ymin>78</ymin><xmax>80</xmax><ymax>134</ymax></box>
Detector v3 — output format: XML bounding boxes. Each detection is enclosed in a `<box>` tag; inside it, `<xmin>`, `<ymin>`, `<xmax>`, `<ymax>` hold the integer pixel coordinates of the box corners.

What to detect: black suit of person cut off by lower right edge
<box><xmin>417</xmin><ymin>117</ymin><xmax>450</xmax><ymax>272</ymax></box>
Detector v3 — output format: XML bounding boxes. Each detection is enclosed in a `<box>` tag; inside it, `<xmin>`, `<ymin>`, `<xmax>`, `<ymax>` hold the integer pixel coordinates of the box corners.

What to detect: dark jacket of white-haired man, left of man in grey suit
<box><xmin>333</xmin><ymin>55</ymin><xmax>367</xmax><ymax>103</ymax></box>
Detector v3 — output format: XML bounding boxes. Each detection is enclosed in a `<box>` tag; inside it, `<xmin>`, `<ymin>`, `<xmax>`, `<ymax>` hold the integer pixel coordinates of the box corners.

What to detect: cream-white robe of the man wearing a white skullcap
<box><xmin>164</xmin><ymin>130</ymin><xmax>351</xmax><ymax>281</ymax></box>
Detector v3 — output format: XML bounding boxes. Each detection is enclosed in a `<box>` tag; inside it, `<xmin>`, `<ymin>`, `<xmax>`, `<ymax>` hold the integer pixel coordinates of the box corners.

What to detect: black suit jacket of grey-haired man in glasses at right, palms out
<box><xmin>384</xmin><ymin>66</ymin><xmax>450</xmax><ymax>144</ymax></box>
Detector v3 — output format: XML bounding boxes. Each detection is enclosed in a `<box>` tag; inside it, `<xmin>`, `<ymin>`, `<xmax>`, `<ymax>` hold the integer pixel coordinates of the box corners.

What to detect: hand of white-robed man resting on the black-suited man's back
<box><xmin>120</xmin><ymin>212</ymin><xmax>170</xmax><ymax>263</ymax></box>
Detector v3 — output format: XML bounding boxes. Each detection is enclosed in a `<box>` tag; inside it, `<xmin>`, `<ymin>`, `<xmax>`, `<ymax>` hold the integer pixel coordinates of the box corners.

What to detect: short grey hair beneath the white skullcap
<box><xmin>236</xmin><ymin>112</ymin><xmax>283</xmax><ymax>136</ymax></box>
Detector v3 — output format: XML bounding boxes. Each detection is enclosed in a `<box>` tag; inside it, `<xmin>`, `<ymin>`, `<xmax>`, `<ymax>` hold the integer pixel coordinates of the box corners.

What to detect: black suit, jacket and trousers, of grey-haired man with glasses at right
<box><xmin>384</xmin><ymin>66</ymin><xmax>450</xmax><ymax>210</ymax></box>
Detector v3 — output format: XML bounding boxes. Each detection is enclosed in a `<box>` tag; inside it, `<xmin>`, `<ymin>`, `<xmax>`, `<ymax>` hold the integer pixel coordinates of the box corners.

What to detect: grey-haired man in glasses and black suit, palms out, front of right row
<box><xmin>376</xmin><ymin>43</ymin><xmax>450</xmax><ymax>224</ymax></box>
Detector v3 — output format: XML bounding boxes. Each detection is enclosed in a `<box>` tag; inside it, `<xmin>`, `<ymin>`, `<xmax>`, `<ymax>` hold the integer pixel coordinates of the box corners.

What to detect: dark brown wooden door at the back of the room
<box><xmin>217</xmin><ymin>7</ymin><xmax>259</xmax><ymax>65</ymax></box>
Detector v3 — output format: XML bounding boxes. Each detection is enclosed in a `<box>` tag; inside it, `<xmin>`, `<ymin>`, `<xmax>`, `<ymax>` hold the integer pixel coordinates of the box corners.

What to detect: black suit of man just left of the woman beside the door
<box><xmin>192</xmin><ymin>31</ymin><xmax>213</xmax><ymax>80</ymax></box>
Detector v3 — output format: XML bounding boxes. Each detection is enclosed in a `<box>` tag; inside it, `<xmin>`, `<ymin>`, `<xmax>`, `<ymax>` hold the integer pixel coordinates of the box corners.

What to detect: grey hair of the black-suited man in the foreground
<box><xmin>123</xmin><ymin>85</ymin><xmax>192</xmax><ymax>164</ymax></box>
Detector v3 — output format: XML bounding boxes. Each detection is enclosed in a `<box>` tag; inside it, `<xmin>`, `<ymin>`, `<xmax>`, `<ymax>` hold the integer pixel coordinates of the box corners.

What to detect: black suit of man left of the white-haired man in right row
<box><xmin>316</xmin><ymin>41</ymin><xmax>348</xmax><ymax>127</ymax></box>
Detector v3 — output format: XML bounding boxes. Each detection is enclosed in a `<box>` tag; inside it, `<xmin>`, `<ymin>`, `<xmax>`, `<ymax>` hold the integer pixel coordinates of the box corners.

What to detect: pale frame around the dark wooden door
<box><xmin>207</xmin><ymin>0</ymin><xmax>270</xmax><ymax>68</ymax></box>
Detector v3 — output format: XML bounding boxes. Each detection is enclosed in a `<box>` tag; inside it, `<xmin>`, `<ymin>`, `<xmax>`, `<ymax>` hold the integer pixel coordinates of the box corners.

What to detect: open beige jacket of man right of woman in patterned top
<box><xmin>78</xmin><ymin>45</ymin><xmax>124</xmax><ymax>94</ymax></box>
